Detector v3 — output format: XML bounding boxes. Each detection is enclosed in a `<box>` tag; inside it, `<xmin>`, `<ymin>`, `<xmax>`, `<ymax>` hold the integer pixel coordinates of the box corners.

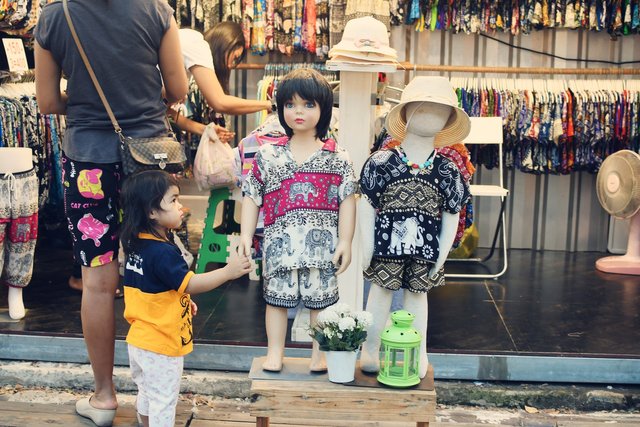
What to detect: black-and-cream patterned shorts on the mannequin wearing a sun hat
<box><xmin>364</xmin><ymin>258</ymin><xmax>444</xmax><ymax>292</ymax></box>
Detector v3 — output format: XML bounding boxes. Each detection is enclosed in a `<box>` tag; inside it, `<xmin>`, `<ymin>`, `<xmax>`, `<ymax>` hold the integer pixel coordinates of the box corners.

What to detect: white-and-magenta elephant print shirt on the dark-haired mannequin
<box><xmin>242</xmin><ymin>137</ymin><xmax>357</xmax><ymax>277</ymax></box>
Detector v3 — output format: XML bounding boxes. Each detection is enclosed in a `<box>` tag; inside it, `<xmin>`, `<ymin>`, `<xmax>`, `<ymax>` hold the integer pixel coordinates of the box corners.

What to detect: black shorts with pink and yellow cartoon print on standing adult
<box><xmin>62</xmin><ymin>156</ymin><xmax>122</xmax><ymax>267</ymax></box>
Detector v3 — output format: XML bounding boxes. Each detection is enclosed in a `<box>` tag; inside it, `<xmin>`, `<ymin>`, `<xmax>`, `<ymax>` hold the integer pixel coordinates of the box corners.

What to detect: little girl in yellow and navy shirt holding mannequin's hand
<box><xmin>121</xmin><ymin>170</ymin><xmax>251</xmax><ymax>426</ymax></box>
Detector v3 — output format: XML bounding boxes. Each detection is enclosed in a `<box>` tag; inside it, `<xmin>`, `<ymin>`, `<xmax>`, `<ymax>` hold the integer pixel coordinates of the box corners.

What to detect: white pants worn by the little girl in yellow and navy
<box><xmin>129</xmin><ymin>344</ymin><xmax>184</xmax><ymax>427</ymax></box>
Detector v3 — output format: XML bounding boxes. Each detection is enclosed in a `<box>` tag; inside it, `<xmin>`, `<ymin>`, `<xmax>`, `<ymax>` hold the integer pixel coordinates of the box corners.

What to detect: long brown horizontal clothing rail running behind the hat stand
<box><xmin>237</xmin><ymin>62</ymin><xmax>640</xmax><ymax>76</ymax></box>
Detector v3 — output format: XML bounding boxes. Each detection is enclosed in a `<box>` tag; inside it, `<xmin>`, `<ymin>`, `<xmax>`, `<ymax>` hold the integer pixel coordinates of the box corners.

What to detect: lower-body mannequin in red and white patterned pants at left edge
<box><xmin>0</xmin><ymin>147</ymin><xmax>38</xmax><ymax>320</ymax></box>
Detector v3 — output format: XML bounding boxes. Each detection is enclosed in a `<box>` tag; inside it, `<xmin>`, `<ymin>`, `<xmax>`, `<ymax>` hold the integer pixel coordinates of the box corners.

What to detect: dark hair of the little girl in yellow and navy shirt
<box><xmin>120</xmin><ymin>170</ymin><xmax>179</xmax><ymax>253</ymax></box>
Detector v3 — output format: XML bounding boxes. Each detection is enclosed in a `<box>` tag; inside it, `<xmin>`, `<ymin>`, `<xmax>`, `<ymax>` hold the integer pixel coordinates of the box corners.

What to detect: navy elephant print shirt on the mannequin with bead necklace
<box><xmin>360</xmin><ymin>149</ymin><xmax>470</xmax><ymax>262</ymax></box>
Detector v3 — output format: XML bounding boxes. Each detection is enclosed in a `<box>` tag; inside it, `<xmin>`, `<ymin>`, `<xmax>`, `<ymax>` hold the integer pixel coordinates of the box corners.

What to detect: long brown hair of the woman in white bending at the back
<box><xmin>204</xmin><ymin>21</ymin><xmax>246</xmax><ymax>94</ymax></box>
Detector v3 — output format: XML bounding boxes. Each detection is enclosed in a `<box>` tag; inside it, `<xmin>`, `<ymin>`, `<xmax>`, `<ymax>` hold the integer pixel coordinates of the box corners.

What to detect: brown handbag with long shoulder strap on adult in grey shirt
<box><xmin>62</xmin><ymin>0</ymin><xmax>187</xmax><ymax>175</ymax></box>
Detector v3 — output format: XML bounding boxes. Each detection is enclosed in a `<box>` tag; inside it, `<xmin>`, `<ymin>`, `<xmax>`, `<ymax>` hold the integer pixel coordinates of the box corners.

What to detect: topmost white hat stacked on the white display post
<box><xmin>329</xmin><ymin>16</ymin><xmax>398</xmax><ymax>62</ymax></box>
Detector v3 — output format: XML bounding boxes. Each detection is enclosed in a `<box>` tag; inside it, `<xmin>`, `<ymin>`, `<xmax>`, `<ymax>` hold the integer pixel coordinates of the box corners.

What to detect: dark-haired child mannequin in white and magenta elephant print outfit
<box><xmin>239</xmin><ymin>69</ymin><xmax>356</xmax><ymax>372</ymax></box>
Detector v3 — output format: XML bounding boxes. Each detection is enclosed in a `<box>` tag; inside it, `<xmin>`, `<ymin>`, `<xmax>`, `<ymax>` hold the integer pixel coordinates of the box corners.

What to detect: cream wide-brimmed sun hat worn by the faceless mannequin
<box><xmin>385</xmin><ymin>76</ymin><xmax>471</xmax><ymax>147</ymax></box>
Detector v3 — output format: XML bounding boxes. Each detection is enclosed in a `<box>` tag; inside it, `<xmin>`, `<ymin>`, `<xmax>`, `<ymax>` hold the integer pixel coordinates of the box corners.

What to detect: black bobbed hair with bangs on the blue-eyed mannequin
<box><xmin>276</xmin><ymin>68</ymin><xmax>333</xmax><ymax>139</ymax></box>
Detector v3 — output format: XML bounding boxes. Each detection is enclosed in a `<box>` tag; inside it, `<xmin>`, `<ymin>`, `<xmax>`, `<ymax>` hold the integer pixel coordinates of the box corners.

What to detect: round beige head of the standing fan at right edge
<box><xmin>596</xmin><ymin>150</ymin><xmax>640</xmax><ymax>219</ymax></box>
